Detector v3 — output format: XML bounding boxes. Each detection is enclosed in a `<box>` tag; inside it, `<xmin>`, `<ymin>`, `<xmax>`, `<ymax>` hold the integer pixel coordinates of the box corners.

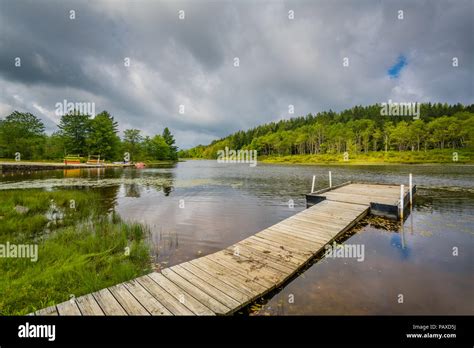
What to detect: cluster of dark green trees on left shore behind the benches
<box><xmin>0</xmin><ymin>111</ymin><xmax>177</xmax><ymax>162</ymax></box>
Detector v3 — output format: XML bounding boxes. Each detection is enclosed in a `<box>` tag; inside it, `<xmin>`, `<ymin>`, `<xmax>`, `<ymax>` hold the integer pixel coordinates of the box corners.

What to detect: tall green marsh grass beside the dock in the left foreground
<box><xmin>0</xmin><ymin>190</ymin><xmax>151</xmax><ymax>315</ymax></box>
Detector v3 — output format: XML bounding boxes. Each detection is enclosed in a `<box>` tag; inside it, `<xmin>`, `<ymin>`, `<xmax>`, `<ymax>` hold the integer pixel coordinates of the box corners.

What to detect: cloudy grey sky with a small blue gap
<box><xmin>0</xmin><ymin>0</ymin><xmax>474</xmax><ymax>148</ymax></box>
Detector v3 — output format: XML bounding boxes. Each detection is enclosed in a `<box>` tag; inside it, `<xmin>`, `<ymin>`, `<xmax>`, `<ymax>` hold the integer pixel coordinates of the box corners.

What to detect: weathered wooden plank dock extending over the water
<box><xmin>32</xmin><ymin>183</ymin><xmax>409</xmax><ymax>315</ymax></box>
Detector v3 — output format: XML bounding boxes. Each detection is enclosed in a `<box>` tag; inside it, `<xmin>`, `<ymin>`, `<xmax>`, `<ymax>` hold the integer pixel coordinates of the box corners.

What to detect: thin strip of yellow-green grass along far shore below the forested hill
<box><xmin>258</xmin><ymin>149</ymin><xmax>474</xmax><ymax>165</ymax></box>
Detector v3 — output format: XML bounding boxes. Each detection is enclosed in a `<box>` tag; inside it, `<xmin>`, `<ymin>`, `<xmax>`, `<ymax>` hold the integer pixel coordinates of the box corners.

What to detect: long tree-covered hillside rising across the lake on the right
<box><xmin>179</xmin><ymin>103</ymin><xmax>474</xmax><ymax>158</ymax></box>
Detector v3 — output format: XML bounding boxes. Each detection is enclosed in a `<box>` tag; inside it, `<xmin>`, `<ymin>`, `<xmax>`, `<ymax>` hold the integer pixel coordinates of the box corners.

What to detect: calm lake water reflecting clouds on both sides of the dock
<box><xmin>0</xmin><ymin>161</ymin><xmax>474</xmax><ymax>315</ymax></box>
